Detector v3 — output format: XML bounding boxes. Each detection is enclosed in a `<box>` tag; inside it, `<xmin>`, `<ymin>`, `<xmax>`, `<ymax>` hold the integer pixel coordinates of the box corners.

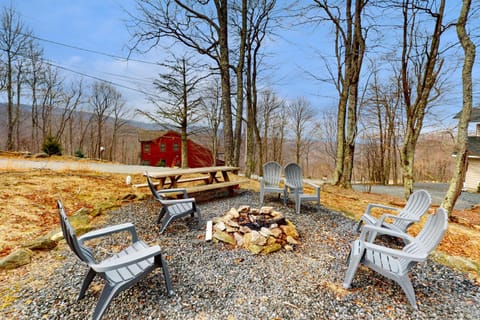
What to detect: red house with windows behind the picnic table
<box><xmin>138</xmin><ymin>130</ymin><xmax>213</xmax><ymax>168</ymax></box>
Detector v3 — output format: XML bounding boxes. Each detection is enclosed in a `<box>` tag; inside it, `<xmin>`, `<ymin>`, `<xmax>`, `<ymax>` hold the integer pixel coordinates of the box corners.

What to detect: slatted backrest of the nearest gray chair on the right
<box><xmin>401</xmin><ymin>208</ymin><xmax>448</xmax><ymax>268</ymax></box>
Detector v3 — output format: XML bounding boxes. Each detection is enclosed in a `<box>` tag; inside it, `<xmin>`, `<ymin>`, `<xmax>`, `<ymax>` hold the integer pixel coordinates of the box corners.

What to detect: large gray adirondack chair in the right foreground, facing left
<box><xmin>343</xmin><ymin>208</ymin><xmax>448</xmax><ymax>309</ymax></box>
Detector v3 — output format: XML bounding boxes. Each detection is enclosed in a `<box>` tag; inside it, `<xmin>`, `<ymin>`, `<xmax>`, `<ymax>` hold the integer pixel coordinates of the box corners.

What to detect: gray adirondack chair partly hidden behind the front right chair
<box><xmin>357</xmin><ymin>190</ymin><xmax>432</xmax><ymax>239</ymax></box>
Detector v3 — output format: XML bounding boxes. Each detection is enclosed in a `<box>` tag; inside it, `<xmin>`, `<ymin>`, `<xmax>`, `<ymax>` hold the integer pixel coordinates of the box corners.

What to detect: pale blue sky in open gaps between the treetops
<box><xmin>0</xmin><ymin>0</ymin><xmax>472</xmax><ymax>129</ymax></box>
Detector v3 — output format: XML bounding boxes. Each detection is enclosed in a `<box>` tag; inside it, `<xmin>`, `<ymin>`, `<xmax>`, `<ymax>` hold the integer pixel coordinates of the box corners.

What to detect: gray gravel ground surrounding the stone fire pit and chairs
<box><xmin>0</xmin><ymin>191</ymin><xmax>480</xmax><ymax>320</ymax></box>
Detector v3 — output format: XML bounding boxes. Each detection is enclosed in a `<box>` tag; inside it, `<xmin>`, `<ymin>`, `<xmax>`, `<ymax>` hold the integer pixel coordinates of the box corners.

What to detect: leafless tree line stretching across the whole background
<box><xmin>0</xmin><ymin>0</ymin><xmax>475</xmax><ymax>215</ymax></box>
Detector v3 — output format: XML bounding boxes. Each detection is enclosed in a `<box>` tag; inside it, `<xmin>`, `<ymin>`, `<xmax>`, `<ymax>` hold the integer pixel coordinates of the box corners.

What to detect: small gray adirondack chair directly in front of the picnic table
<box><xmin>145</xmin><ymin>172</ymin><xmax>202</xmax><ymax>234</ymax></box>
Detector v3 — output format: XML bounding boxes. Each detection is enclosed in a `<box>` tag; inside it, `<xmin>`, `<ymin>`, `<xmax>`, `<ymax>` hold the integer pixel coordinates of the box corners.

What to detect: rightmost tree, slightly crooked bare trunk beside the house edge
<box><xmin>441</xmin><ymin>0</ymin><xmax>476</xmax><ymax>213</ymax></box>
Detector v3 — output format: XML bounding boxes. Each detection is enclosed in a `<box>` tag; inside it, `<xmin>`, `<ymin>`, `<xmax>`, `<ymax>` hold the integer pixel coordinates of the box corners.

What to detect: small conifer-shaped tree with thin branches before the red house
<box><xmin>138</xmin><ymin>56</ymin><xmax>204</xmax><ymax>168</ymax></box>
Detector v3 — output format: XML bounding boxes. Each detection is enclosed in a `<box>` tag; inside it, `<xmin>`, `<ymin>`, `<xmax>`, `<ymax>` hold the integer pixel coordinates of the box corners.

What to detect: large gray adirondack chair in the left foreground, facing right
<box><xmin>57</xmin><ymin>200</ymin><xmax>174</xmax><ymax>320</ymax></box>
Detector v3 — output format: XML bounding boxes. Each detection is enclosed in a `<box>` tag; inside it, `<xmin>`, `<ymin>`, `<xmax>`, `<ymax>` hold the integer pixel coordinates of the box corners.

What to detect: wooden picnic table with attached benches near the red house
<box><xmin>143</xmin><ymin>166</ymin><xmax>248</xmax><ymax>193</ymax></box>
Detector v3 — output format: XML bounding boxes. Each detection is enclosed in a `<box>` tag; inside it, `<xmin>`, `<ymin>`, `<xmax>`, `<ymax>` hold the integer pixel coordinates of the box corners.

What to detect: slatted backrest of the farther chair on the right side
<box><xmin>393</xmin><ymin>190</ymin><xmax>432</xmax><ymax>230</ymax></box>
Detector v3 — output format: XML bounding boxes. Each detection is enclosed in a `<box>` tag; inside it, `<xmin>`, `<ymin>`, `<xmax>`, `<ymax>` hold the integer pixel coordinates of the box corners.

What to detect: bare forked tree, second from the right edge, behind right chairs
<box><xmin>400</xmin><ymin>0</ymin><xmax>445</xmax><ymax>198</ymax></box>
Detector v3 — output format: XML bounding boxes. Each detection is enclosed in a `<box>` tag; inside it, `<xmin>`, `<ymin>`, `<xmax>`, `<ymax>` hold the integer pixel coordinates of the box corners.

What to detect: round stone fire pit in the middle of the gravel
<box><xmin>212</xmin><ymin>206</ymin><xmax>300</xmax><ymax>254</ymax></box>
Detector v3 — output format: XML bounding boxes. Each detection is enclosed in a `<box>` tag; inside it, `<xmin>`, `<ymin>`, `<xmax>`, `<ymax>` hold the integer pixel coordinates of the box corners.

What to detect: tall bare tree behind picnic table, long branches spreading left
<box><xmin>132</xmin><ymin>0</ymin><xmax>235</xmax><ymax>165</ymax></box>
